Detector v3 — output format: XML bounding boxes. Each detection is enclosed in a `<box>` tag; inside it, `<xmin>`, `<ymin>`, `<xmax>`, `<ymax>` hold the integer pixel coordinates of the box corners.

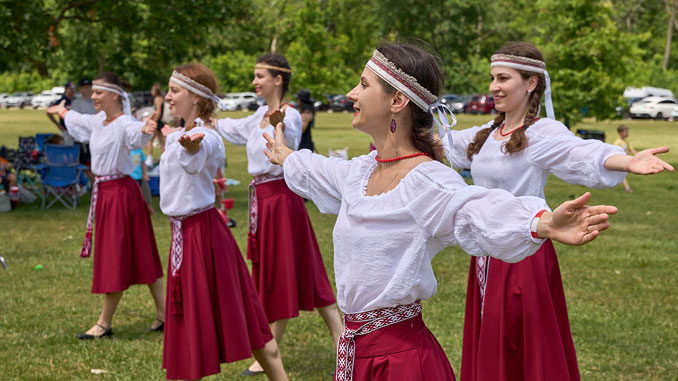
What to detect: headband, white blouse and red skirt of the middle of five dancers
<box><xmin>217</xmin><ymin>63</ymin><xmax>336</xmax><ymax>323</ymax></box>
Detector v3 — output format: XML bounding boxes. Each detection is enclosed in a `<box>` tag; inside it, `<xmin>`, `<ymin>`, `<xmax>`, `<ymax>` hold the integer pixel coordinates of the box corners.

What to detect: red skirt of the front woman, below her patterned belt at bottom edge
<box><xmin>346</xmin><ymin>314</ymin><xmax>455</xmax><ymax>381</ymax></box>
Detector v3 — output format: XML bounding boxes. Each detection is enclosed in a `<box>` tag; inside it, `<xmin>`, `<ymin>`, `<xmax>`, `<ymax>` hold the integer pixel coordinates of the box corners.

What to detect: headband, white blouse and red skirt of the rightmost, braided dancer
<box><xmin>444</xmin><ymin>55</ymin><xmax>626</xmax><ymax>381</ymax></box>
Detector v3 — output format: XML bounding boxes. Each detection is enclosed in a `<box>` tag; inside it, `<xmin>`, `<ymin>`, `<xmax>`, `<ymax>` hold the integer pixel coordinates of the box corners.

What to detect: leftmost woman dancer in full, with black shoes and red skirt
<box><xmin>47</xmin><ymin>72</ymin><xmax>165</xmax><ymax>340</ymax></box>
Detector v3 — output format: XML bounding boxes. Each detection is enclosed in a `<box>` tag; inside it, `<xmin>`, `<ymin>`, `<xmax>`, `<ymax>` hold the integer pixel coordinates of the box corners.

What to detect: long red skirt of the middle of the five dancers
<box><xmin>247</xmin><ymin>180</ymin><xmax>336</xmax><ymax>322</ymax></box>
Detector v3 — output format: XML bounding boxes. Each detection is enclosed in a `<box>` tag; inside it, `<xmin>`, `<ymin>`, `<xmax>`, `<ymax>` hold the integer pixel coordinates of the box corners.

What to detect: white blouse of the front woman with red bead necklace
<box><xmin>284</xmin><ymin>149</ymin><xmax>548</xmax><ymax>313</ymax></box>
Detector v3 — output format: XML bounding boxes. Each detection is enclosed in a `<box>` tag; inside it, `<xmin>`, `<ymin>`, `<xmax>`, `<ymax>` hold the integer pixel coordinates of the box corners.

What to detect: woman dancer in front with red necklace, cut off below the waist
<box><xmin>266</xmin><ymin>44</ymin><xmax>616</xmax><ymax>381</ymax></box>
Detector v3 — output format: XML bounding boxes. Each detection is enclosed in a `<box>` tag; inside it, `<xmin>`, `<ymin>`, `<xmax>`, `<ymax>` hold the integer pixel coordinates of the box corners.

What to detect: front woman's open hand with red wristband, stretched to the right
<box><xmin>537</xmin><ymin>192</ymin><xmax>617</xmax><ymax>246</ymax></box>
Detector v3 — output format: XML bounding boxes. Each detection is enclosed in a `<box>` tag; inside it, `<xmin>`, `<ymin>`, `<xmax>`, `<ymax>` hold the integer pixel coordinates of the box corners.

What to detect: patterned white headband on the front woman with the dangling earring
<box><xmin>365</xmin><ymin>50</ymin><xmax>438</xmax><ymax>111</ymax></box>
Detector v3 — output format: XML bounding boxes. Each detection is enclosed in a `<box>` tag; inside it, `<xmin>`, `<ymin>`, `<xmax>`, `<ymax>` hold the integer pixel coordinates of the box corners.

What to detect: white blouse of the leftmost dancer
<box><xmin>64</xmin><ymin>110</ymin><xmax>153</xmax><ymax>176</ymax></box>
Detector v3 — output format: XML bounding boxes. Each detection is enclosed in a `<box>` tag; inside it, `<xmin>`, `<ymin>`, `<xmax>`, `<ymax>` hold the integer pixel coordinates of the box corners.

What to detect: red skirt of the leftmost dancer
<box><xmin>92</xmin><ymin>176</ymin><xmax>162</xmax><ymax>294</ymax></box>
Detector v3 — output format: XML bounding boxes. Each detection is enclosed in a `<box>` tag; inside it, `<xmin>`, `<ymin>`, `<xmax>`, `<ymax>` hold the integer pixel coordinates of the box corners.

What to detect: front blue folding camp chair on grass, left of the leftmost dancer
<box><xmin>36</xmin><ymin>144</ymin><xmax>87</xmax><ymax>210</ymax></box>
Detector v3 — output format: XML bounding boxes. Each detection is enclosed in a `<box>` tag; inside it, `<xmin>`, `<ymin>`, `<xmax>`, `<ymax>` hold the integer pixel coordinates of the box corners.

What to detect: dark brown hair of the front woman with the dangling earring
<box><xmin>377</xmin><ymin>43</ymin><xmax>442</xmax><ymax>161</ymax></box>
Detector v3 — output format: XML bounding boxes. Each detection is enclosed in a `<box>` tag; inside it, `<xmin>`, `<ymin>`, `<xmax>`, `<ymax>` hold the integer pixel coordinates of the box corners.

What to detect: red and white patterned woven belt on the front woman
<box><xmin>336</xmin><ymin>301</ymin><xmax>421</xmax><ymax>381</ymax></box>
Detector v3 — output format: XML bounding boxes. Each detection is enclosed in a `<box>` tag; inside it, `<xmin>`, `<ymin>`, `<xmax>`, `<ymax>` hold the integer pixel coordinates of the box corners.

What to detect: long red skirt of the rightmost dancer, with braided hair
<box><xmin>461</xmin><ymin>240</ymin><xmax>579</xmax><ymax>381</ymax></box>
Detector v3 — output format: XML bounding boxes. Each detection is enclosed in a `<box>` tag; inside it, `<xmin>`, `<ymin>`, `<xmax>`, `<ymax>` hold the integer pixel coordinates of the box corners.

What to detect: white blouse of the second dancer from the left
<box><xmin>160</xmin><ymin>127</ymin><xmax>226</xmax><ymax>216</ymax></box>
